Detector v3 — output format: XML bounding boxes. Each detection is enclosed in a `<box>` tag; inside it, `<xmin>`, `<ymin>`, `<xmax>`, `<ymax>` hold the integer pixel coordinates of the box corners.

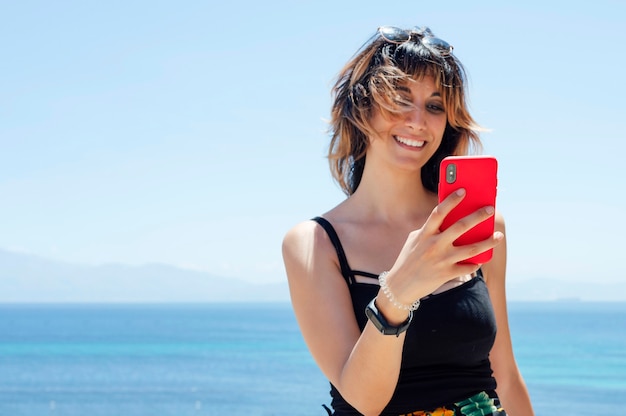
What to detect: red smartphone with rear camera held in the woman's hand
<box><xmin>438</xmin><ymin>156</ymin><xmax>498</xmax><ymax>264</ymax></box>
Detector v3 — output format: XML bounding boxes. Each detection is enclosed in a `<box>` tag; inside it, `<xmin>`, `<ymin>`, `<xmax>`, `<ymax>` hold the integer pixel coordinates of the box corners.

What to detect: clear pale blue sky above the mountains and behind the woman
<box><xmin>0</xmin><ymin>0</ymin><xmax>626</xmax><ymax>290</ymax></box>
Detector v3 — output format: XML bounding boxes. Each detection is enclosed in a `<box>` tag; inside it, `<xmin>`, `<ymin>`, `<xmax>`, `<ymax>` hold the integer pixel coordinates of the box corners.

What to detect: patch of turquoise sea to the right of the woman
<box><xmin>509</xmin><ymin>302</ymin><xmax>626</xmax><ymax>415</ymax></box>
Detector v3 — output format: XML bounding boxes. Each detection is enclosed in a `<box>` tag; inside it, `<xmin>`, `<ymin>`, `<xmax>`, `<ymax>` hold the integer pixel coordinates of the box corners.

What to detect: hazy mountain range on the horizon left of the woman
<box><xmin>0</xmin><ymin>250</ymin><xmax>289</xmax><ymax>302</ymax></box>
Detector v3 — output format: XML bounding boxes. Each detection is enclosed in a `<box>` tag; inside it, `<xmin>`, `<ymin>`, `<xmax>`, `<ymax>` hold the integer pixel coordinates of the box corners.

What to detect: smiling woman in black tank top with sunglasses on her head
<box><xmin>283</xmin><ymin>27</ymin><xmax>533</xmax><ymax>416</ymax></box>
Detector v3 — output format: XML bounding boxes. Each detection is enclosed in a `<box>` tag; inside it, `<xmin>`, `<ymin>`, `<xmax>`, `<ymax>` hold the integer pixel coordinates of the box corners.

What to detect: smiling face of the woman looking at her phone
<box><xmin>367</xmin><ymin>76</ymin><xmax>447</xmax><ymax>170</ymax></box>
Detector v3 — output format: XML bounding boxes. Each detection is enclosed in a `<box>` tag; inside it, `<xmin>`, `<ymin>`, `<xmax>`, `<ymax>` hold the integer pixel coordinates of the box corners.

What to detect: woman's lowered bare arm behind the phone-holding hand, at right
<box><xmin>482</xmin><ymin>214</ymin><xmax>534</xmax><ymax>416</ymax></box>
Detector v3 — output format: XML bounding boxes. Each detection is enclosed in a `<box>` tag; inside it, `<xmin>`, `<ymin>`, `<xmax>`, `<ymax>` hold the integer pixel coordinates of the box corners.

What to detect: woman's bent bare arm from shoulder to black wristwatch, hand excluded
<box><xmin>283</xmin><ymin>221</ymin><xmax>407</xmax><ymax>415</ymax></box>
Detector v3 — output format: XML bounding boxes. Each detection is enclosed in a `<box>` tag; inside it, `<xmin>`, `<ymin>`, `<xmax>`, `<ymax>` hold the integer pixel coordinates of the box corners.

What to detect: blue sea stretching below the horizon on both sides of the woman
<box><xmin>0</xmin><ymin>301</ymin><xmax>626</xmax><ymax>416</ymax></box>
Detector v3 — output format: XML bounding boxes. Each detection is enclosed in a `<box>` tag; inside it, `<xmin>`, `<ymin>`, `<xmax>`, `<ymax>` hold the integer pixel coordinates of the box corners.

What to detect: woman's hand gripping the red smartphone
<box><xmin>387</xmin><ymin>189</ymin><xmax>504</xmax><ymax>305</ymax></box>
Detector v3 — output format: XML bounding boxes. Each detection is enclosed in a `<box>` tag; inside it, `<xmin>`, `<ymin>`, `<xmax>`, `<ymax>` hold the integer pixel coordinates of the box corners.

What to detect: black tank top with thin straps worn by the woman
<box><xmin>313</xmin><ymin>217</ymin><xmax>496</xmax><ymax>416</ymax></box>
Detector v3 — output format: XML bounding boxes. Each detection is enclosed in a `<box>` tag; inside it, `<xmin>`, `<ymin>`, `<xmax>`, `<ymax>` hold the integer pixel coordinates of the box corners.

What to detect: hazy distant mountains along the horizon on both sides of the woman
<box><xmin>0</xmin><ymin>250</ymin><xmax>626</xmax><ymax>303</ymax></box>
